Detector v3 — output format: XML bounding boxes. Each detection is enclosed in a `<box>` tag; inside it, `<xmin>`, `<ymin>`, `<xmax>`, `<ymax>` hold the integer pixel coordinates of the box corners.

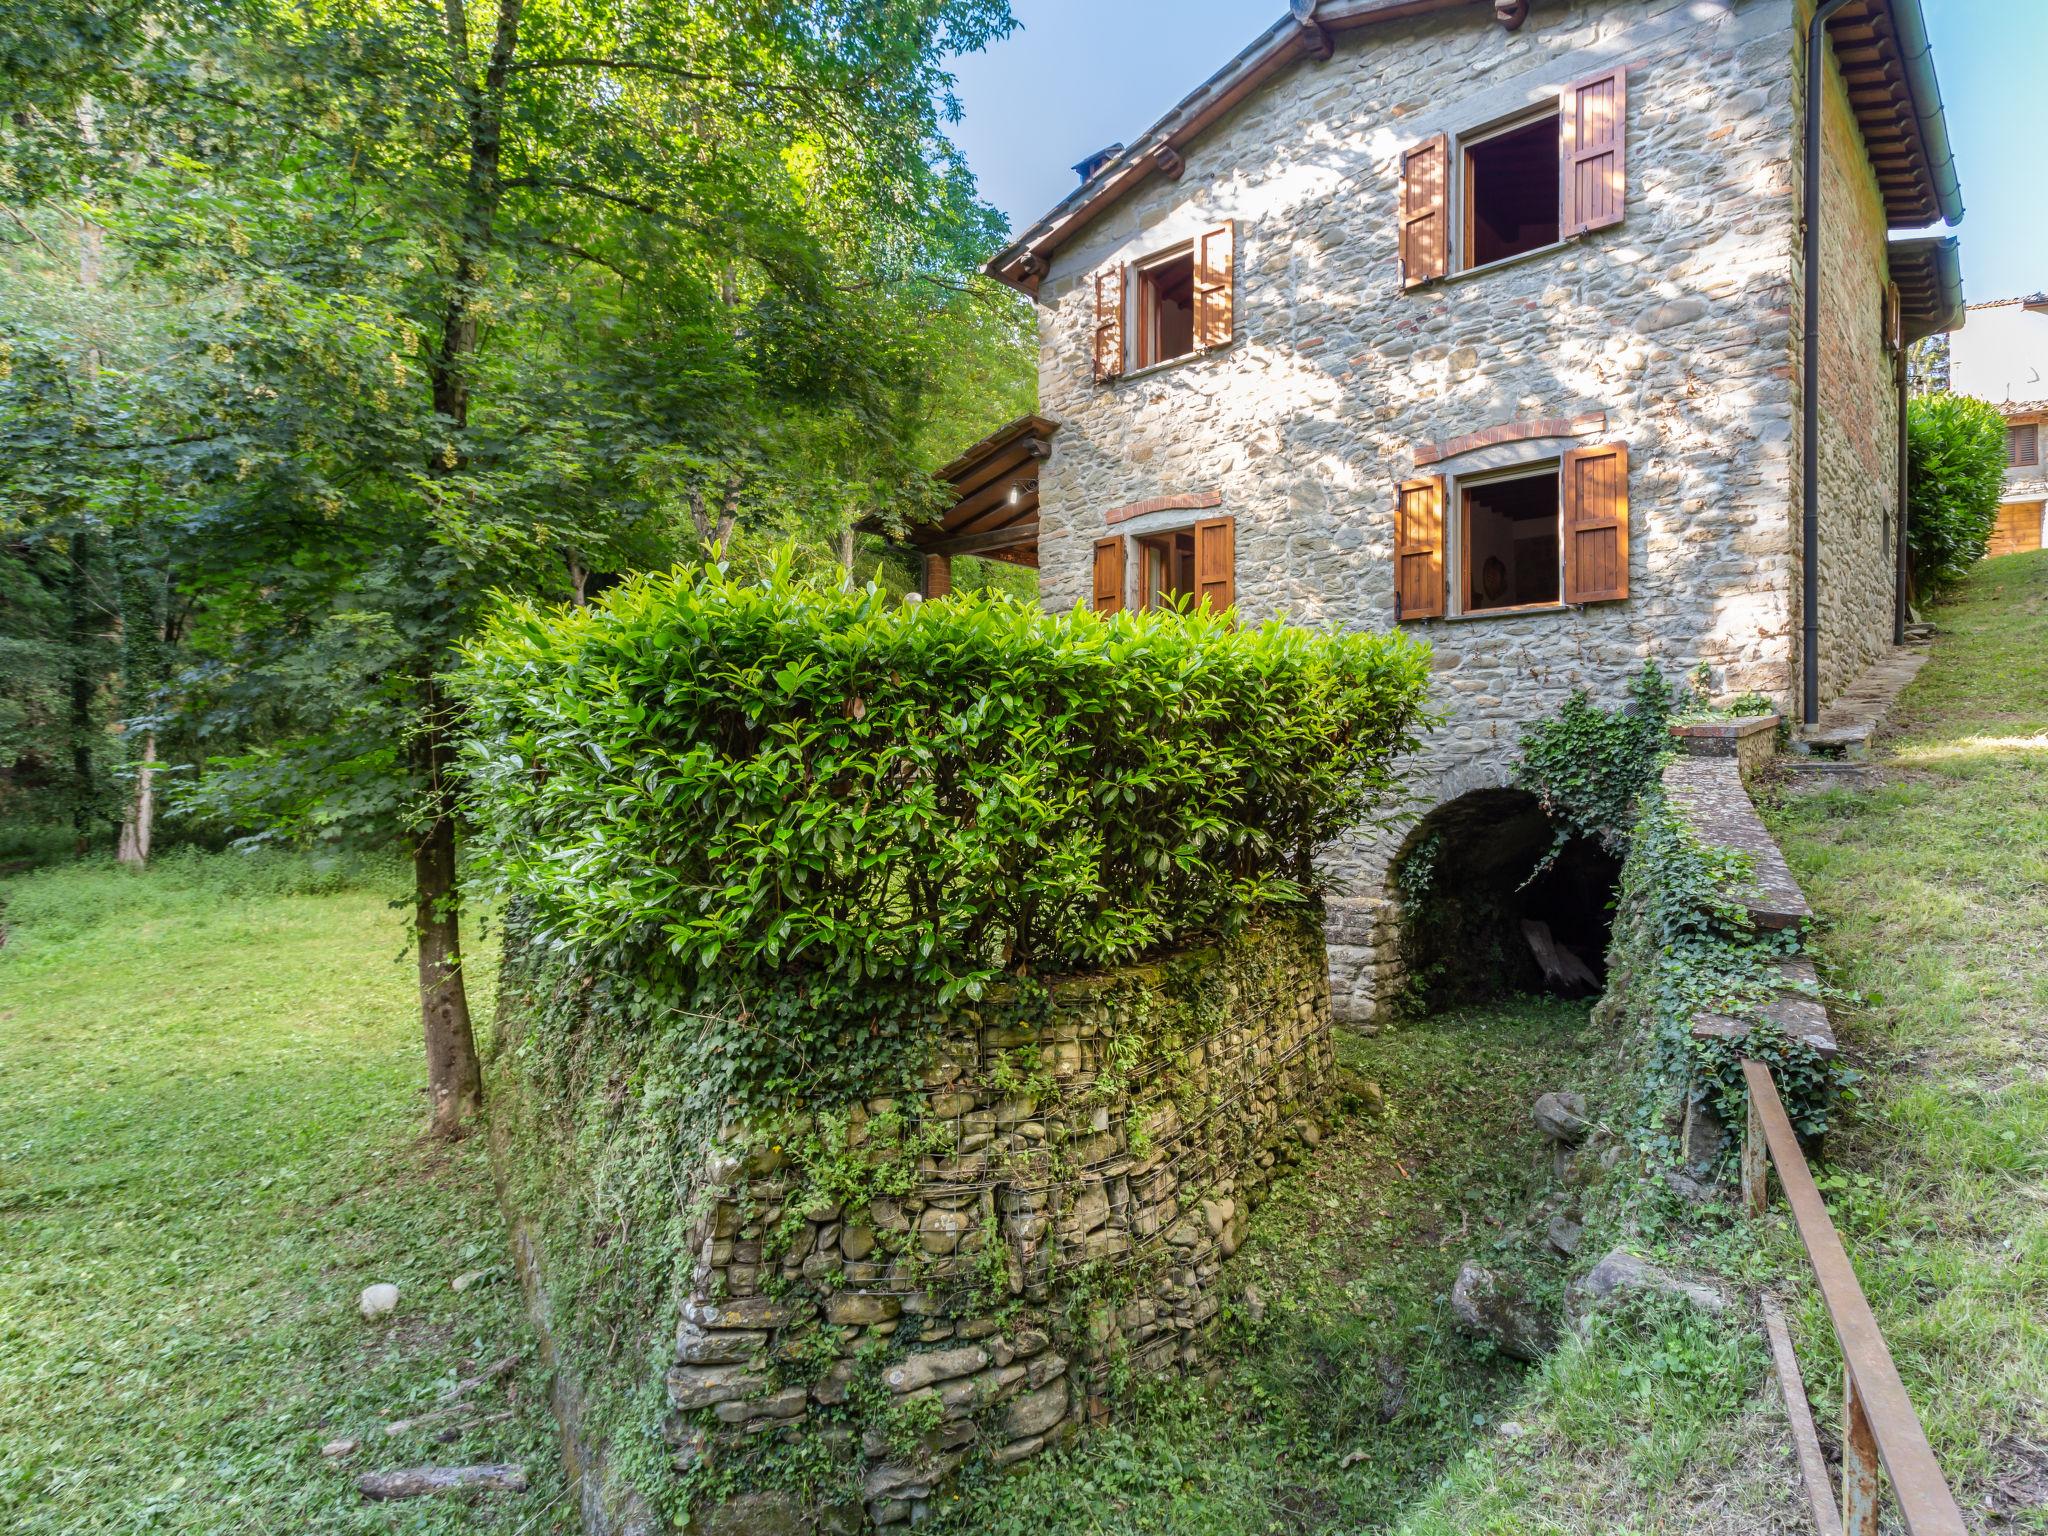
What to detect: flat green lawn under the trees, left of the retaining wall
<box><xmin>0</xmin><ymin>856</ymin><xmax>573</xmax><ymax>1536</ymax></box>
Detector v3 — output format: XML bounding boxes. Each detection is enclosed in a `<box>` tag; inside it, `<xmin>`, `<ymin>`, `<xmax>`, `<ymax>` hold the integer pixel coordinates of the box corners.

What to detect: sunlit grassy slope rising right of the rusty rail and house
<box><xmin>1767</xmin><ymin>555</ymin><xmax>2048</xmax><ymax>1530</ymax></box>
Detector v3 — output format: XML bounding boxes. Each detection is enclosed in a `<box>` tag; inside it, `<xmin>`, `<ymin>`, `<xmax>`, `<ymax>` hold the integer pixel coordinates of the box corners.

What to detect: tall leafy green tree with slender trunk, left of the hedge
<box><xmin>0</xmin><ymin>0</ymin><xmax>1012</xmax><ymax>1135</ymax></box>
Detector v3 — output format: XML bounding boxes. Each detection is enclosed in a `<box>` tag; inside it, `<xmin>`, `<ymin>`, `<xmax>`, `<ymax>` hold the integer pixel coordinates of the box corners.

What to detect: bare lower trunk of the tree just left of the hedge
<box><xmin>412</xmin><ymin>678</ymin><xmax>483</xmax><ymax>1137</ymax></box>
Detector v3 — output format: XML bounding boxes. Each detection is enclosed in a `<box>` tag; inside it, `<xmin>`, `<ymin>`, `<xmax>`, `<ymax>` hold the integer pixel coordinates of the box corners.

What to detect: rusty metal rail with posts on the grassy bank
<box><xmin>1743</xmin><ymin>1061</ymin><xmax>1968</xmax><ymax>1536</ymax></box>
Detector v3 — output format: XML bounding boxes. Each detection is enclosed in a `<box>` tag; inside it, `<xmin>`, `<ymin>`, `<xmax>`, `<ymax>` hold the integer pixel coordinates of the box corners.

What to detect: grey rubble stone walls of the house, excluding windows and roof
<box><xmin>1038</xmin><ymin>0</ymin><xmax>1896</xmax><ymax>1036</ymax></box>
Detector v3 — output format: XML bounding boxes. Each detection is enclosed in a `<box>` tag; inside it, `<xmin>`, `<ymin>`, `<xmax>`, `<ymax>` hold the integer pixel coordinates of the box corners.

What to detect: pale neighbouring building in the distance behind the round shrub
<box><xmin>1948</xmin><ymin>293</ymin><xmax>2048</xmax><ymax>557</ymax></box>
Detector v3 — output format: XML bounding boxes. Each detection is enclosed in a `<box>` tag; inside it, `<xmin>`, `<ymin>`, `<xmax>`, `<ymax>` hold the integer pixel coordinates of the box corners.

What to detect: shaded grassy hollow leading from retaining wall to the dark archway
<box><xmin>929</xmin><ymin>999</ymin><xmax>1646</xmax><ymax>1536</ymax></box>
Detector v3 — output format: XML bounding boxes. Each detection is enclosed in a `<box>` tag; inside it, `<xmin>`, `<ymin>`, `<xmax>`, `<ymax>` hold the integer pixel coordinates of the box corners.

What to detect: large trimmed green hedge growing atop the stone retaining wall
<box><xmin>461</xmin><ymin>569</ymin><xmax>1430</xmax><ymax>1105</ymax></box>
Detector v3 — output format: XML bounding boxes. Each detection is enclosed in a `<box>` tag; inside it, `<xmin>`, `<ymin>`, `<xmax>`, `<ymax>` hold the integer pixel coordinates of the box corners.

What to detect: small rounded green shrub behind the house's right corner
<box><xmin>1907</xmin><ymin>395</ymin><xmax>2005</xmax><ymax>594</ymax></box>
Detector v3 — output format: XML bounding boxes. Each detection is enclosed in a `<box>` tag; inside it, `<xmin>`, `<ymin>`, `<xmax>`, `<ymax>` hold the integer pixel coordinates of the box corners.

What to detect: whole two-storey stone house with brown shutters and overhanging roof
<box><xmin>918</xmin><ymin>0</ymin><xmax>1962</xmax><ymax>1036</ymax></box>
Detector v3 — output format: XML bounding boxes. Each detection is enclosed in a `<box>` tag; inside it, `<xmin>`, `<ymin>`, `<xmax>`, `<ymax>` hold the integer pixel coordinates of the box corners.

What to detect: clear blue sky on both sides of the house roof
<box><xmin>954</xmin><ymin>0</ymin><xmax>2048</xmax><ymax>301</ymax></box>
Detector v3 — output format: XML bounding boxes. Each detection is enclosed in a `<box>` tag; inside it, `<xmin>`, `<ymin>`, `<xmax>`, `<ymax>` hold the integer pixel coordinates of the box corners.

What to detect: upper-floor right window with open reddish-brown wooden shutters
<box><xmin>1397</xmin><ymin>70</ymin><xmax>1628</xmax><ymax>289</ymax></box>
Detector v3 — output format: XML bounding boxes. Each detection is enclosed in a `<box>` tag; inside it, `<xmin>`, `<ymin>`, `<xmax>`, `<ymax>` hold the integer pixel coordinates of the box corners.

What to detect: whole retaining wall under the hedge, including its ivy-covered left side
<box><xmin>494</xmin><ymin>915</ymin><xmax>1333</xmax><ymax>1532</ymax></box>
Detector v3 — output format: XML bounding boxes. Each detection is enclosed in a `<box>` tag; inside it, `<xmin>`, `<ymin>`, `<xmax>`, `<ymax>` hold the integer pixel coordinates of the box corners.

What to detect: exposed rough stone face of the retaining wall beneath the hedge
<box><xmin>668</xmin><ymin>918</ymin><xmax>1335</xmax><ymax>1530</ymax></box>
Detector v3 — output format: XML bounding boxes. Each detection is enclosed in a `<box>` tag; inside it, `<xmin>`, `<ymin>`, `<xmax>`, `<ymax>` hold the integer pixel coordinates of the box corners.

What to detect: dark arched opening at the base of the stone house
<box><xmin>1389</xmin><ymin>788</ymin><xmax>1620</xmax><ymax>1012</ymax></box>
